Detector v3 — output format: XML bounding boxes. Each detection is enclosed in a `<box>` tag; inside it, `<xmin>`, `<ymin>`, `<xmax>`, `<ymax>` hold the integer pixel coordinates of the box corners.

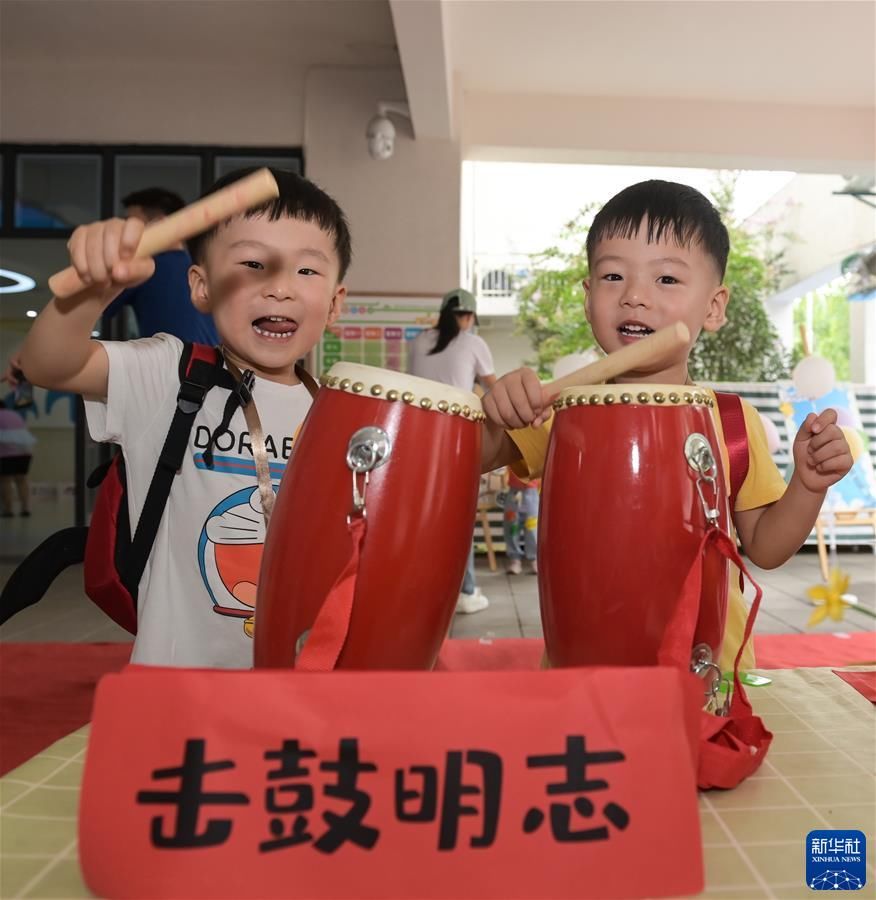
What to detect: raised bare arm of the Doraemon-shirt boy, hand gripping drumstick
<box><xmin>21</xmin><ymin>219</ymin><xmax>155</xmax><ymax>398</ymax></box>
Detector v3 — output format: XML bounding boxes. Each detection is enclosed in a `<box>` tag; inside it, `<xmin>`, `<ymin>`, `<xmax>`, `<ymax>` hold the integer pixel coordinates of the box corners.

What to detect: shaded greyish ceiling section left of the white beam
<box><xmin>0</xmin><ymin>0</ymin><xmax>398</xmax><ymax>70</ymax></box>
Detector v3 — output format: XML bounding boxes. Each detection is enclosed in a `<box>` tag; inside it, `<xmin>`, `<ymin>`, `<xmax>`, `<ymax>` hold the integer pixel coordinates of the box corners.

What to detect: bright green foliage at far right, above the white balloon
<box><xmin>791</xmin><ymin>277</ymin><xmax>851</xmax><ymax>381</ymax></box>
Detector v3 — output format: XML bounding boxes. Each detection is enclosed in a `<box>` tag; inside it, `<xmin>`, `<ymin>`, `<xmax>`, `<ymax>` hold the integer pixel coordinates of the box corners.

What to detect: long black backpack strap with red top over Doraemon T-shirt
<box><xmin>121</xmin><ymin>342</ymin><xmax>227</xmax><ymax>597</ymax></box>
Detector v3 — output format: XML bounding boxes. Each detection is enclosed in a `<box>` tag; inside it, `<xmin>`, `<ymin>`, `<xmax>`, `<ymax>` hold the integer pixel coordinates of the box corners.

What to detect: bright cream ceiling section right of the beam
<box><xmin>444</xmin><ymin>0</ymin><xmax>876</xmax><ymax>106</ymax></box>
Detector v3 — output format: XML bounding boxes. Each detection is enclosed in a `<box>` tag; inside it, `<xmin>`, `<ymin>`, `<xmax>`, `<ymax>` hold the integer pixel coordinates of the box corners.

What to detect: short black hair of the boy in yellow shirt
<box><xmin>587</xmin><ymin>180</ymin><xmax>730</xmax><ymax>281</ymax></box>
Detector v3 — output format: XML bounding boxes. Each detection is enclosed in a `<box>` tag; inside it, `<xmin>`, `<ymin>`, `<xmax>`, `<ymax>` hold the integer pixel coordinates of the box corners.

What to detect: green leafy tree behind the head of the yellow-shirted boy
<box><xmin>518</xmin><ymin>175</ymin><xmax>788</xmax><ymax>381</ymax></box>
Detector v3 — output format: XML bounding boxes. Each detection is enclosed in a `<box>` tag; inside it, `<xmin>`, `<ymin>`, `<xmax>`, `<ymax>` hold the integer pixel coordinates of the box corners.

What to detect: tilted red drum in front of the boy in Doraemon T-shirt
<box><xmin>255</xmin><ymin>363</ymin><xmax>484</xmax><ymax>669</ymax></box>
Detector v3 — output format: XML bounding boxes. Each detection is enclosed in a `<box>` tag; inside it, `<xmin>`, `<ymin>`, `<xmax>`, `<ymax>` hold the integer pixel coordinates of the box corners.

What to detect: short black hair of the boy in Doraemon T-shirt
<box><xmin>188</xmin><ymin>166</ymin><xmax>353</xmax><ymax>281</ymax></box>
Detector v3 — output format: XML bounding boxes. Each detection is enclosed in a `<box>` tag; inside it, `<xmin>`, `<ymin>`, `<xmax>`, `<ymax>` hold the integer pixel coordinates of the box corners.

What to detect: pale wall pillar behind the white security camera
<box><xmin>304</xmin><ymin>68</ymin><xmax>461</xmax><ymax>294</ymax></box>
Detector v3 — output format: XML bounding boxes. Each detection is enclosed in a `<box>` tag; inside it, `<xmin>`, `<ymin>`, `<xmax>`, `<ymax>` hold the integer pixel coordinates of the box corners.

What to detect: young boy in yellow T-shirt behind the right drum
<box><xmin>484</xmin><ymin>181</ymin><xmax>852</xmax><ymax>670</ymax></box>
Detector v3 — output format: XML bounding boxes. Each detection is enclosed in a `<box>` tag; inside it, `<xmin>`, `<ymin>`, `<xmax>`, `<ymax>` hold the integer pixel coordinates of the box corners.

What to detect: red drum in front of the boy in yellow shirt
<box><xmin>538</xmin><ymin>384</ymin><xmax>728</xmax><ymax>671</ymax></box>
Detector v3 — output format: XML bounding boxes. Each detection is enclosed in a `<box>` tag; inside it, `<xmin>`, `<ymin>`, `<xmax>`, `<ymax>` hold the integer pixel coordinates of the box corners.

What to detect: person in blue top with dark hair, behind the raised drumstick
<box><xmin>104</xmin><ymin>188</ymin><xmax>219</xmax><ymax>346</ymax></box>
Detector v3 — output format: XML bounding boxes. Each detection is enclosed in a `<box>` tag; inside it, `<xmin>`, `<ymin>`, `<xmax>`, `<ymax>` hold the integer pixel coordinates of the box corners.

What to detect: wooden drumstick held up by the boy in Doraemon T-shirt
<box><xmin>49</xmin><ymin>169</ymin><xmax>280</xmax><ymax>299</ymax></box>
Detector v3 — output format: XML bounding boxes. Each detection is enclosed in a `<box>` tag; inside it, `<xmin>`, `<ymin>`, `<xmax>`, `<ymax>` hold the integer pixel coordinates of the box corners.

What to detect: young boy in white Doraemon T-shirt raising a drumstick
<box><xmin>22</xmin><ymin>171</ymin><xmax>351</xmax><ymax>668</ymax></box>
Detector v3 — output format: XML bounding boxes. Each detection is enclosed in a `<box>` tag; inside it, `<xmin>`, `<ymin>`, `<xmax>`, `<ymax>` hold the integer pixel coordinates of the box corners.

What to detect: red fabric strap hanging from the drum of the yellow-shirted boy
<box><xmin>658</xmin><ymin>528</ymin><xmax>773</xmax><ymax>789</ymax></box>
